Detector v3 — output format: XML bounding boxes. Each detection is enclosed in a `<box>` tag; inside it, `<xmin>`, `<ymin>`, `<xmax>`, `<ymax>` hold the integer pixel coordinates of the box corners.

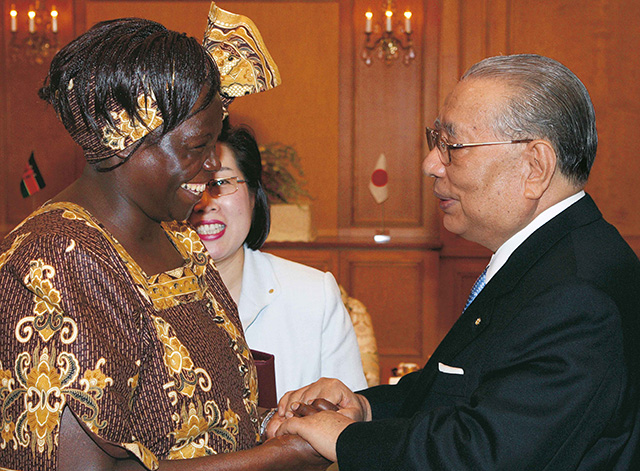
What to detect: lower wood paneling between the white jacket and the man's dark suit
<box><xmin>265</xmin><ymin>240</ymin><xmax>440</xmax><ymax>382</ymax></box>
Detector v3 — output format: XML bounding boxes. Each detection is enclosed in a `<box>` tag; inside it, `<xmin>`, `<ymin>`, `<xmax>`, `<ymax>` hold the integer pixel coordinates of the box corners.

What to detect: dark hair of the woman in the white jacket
<box><xmin>218</xmin><ymin>119</ymin><xmax>271</xmax><ymax>250</ymax></box>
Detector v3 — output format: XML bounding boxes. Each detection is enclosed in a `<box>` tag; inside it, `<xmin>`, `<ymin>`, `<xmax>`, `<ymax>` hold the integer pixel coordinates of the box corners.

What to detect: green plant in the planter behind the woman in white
<box><xmin>260</xmin><ymin>142</ymin><xmax>313</xmax><ymax>204</ymax></box>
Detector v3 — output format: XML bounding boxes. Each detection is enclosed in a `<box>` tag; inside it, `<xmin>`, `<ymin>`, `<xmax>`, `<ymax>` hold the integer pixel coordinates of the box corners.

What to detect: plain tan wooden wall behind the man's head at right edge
<box><xmin>502</xmin><ymin>0</ymin><xmax>640</xmax><ymax>247</ymax></box>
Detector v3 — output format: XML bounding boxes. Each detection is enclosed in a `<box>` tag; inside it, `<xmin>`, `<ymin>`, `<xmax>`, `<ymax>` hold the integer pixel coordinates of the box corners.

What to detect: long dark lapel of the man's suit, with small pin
<box><xmin>399</xmin><ymin>195</ymin><xmax>602</xmax><ymax>417</ymax></box>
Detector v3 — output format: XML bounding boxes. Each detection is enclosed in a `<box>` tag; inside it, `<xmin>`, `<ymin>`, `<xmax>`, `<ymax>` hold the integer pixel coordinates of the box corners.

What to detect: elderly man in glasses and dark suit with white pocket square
<box><xmin>270</xmin><ymin>55</ymin><xmax>640</xmax><ymax>471</ymax></box>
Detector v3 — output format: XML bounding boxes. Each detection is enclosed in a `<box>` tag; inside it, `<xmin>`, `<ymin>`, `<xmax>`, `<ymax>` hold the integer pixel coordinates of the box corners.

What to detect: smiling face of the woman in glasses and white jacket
<box><xmin>189</xmin><ymin>143</ymin><xmax>255</xmax><ymax>262</ymax></box>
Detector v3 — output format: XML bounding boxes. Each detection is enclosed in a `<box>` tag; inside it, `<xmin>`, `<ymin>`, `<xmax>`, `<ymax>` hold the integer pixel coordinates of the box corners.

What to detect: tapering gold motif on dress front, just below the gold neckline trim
<box><xmin>153</xmin><ymin>316</ymin><xmax>211</xmax><ymax>399</ymax></box>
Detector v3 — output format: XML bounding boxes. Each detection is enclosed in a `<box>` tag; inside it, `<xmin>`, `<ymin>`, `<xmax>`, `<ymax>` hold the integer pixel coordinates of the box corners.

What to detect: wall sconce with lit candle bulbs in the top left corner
<box><xmin>9</xmin><ymin>1</ymin><xmax>58</xmax><ymax>64</ymax></box>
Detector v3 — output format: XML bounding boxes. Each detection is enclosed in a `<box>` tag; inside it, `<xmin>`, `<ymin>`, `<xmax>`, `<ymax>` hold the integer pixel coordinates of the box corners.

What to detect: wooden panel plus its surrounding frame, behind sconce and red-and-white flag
<box><xmin>339</xmin><ymin>0</ymin><xmax>437</xmax><ymax>239</ymax></box>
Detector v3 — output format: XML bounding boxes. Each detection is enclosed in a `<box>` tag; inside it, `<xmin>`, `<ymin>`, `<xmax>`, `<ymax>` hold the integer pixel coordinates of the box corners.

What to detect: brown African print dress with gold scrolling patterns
<box><xmin>0</xmin><ymin>203</ymin><xmax>258</xmax><ymax>471</ymax></box>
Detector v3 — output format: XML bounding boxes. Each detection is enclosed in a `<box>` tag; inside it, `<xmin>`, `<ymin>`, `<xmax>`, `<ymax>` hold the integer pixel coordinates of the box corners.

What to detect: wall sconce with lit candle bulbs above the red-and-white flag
<box><xmin>362</xmin><ymin>0</ymin><xmax>416</xmax><ymax>65</ymax></box>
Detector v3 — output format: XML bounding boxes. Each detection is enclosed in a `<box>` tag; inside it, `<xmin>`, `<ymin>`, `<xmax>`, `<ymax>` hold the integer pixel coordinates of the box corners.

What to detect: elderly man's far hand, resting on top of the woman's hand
<box><xmin>278</xmin><ymin>378</ymin><xmax>371</xmax><ymax>422</ymax></box>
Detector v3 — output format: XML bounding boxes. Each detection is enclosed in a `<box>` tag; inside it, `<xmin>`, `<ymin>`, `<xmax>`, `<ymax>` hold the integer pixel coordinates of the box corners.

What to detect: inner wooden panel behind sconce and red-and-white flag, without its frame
<box><xmin>352</xmin><ymin>0</ymin><xmax>424</xmax><ymax>227</ymax></box>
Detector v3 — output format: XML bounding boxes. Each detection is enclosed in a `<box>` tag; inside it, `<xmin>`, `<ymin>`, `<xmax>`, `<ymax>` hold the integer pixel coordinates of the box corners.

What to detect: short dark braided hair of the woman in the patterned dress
<box><xmin>39</xmin><ymin>18</ymin><xmax>220</xmax><ymax>170</ymax></box>
